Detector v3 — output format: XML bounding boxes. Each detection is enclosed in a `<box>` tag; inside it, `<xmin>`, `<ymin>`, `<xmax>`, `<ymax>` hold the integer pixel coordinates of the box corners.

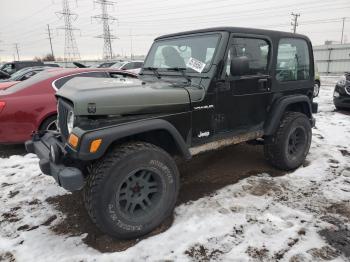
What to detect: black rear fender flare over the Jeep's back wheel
<box><xmin>264</xmin><ymin>95</ymin><xmax>312</xmax><ymax>135</ymax></box>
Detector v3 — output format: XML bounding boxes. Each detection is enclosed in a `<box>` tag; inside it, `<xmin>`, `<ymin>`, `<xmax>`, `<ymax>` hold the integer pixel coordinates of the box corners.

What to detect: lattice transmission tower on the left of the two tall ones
<box><xmin>57</xmin><ymin>0</ymin><xmax>80</xmax><ymax>61</ymax></box>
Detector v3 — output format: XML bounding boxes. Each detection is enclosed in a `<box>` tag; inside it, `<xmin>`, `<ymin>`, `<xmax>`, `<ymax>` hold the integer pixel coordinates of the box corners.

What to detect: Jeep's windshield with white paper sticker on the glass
<box><xmin>144</xmin><ymin>34</ymin><xmax>220</xmax><ymax>73</ymax></box>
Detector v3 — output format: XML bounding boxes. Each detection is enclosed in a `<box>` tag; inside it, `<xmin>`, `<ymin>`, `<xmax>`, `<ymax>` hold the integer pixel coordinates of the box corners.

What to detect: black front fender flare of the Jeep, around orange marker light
<box><xmin>71</xmin><ymin>119</ymin><xmax>191</xmax><ymax>161</ymax></box>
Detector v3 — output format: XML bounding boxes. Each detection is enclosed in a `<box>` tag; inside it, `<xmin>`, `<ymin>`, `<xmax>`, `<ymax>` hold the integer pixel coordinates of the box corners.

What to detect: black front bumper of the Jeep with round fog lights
<box><xmin>25</xmin><ymin>132</ymin><xmax>84</xmax><ymax>191</ymax></box>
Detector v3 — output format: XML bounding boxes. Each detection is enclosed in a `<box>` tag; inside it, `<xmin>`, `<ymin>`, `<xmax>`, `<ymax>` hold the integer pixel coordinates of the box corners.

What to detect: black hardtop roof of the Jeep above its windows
<box><xmin>155</xmin><ymin>27</ymin><xmax>310</xmax><ymax>41</ymax></box>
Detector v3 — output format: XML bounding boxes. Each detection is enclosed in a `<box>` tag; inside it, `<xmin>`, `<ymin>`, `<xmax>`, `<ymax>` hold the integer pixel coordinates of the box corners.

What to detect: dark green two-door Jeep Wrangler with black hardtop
<box><xmin>26</xmin><ymin>27</ymin><xmax>317</xmax><ymax>239</ymax></box>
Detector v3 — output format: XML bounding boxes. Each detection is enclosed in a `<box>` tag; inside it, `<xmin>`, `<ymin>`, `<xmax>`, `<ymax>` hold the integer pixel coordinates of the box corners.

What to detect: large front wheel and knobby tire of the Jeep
<box><xmin>83</xmin><ymin>142</ymin><xmax>179</xmax><ymax>239</ymax></box>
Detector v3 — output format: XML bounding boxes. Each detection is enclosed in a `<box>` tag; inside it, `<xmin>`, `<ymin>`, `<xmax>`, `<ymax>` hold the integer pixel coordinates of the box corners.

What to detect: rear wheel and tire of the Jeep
<box><xmin>264</xmin><ymin>112</ymin><xmax>312</xmax><ymax>171</ymax></box>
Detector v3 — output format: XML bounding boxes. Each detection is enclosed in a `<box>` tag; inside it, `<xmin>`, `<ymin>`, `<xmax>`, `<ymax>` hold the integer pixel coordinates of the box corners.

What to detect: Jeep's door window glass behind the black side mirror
<box><xmin>225</xmin><ymin>38</ymin><xmax>271</xmax><ymax>76</ymax></box>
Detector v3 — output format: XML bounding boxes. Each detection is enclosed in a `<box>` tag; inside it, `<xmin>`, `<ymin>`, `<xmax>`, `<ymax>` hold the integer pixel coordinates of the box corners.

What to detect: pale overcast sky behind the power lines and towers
<box><xmin>0</xmin><ymin>0</ymin><xmax>350</xmax><ymax>61</ymax></box>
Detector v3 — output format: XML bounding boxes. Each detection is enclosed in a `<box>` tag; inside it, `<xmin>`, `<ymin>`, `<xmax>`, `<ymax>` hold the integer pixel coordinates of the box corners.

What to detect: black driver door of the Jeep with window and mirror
<box><xmin>215</xmin><ymin>36</ymin><xmax>272</xmax><ymax>134</ymax></box>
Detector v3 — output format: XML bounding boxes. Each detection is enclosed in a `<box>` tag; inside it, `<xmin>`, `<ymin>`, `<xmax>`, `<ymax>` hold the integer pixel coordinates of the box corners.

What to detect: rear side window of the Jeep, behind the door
<box><xmin>276</xmin><ymin>38</ymin><xmax>310</xmax><ymax>82</ymax></box>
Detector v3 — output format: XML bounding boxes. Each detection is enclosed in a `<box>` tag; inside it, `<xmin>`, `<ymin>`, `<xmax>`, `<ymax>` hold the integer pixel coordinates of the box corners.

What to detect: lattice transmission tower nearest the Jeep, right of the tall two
<box><xmin>93</xmin><ymin>0</ymin><xmax>117</xmax><ymax>60</ymax></box>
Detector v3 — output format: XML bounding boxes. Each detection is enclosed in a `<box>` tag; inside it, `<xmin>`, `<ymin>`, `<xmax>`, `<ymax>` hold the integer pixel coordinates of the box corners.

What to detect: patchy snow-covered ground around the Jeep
<box><xmin>0</xmin><ymin>82</ymin><xmax>350</xmax><ymax>262</ymax></box>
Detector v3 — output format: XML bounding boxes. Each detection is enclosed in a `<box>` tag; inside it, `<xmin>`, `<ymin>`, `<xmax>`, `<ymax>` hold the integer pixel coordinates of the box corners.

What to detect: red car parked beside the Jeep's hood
<box><xmin>0</xmin><ymin>68</ymin><xmax>137</xmax><ymax>144</ymax></box>
